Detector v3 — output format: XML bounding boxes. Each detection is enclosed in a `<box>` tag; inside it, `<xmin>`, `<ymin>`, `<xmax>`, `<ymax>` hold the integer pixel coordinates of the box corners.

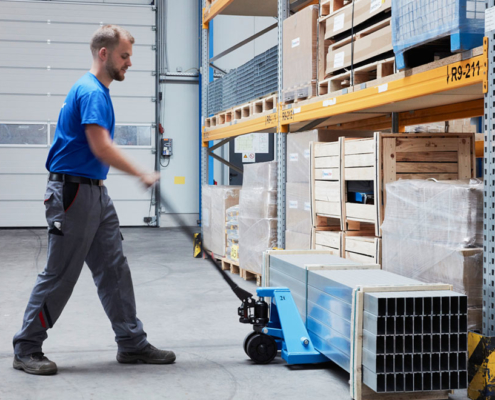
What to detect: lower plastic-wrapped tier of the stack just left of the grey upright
<box><xmin>239</xmin><ymin>217</ymin><xmax>277</xmax><ymax>274</ymax></box>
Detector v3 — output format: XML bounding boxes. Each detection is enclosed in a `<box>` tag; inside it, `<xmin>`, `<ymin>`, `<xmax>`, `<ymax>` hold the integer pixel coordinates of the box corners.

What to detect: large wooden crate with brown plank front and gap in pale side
<box><xmin>342</xmin><ymin>133</ymin><xmax>476</xmax><ymax>236</ymax></box>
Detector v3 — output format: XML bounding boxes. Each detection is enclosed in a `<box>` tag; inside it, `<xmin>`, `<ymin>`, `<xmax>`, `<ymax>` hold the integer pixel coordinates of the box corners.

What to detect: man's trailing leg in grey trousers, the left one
<box><xmin>14</xmin><ymin>181</ymin><xmax>101</xmax><ymax>372</ymax></box>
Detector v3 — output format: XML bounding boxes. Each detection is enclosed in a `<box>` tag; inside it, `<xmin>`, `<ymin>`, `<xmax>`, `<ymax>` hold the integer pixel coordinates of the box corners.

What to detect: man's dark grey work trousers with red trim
<box><xmin>14</xmin><ymin>181</ymin><xmax>148</xmax><ymax>355</ymax></box>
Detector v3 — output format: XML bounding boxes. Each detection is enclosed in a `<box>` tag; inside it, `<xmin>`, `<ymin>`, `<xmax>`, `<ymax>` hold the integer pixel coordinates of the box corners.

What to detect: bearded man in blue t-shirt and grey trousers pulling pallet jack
<box><xmin>13</xmin><ymin>25</ymin><xmax>175</xmax><ymax>375</ymax></box>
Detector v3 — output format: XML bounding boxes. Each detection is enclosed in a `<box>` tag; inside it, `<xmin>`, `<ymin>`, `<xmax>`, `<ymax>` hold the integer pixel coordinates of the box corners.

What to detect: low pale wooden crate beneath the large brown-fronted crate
<box><xmin>342</xmin><ymin>231</ymin><xmax>382</xmax><ymax>265</ymax></box>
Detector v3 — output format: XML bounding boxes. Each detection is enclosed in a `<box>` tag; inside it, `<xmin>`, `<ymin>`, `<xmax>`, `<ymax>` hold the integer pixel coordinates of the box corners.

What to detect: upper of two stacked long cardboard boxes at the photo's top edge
<box><xmin>325</xmin><ymin>0</ymin><xmax>392</xmax><ymax>39</ymax></box>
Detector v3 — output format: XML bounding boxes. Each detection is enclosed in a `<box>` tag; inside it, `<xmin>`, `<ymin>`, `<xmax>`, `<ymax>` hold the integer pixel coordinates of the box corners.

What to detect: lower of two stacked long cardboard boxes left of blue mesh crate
<box><xmin>325</xmin><ymin>18</ymin><xmax>393</xmax><ymax>74</ymax></box>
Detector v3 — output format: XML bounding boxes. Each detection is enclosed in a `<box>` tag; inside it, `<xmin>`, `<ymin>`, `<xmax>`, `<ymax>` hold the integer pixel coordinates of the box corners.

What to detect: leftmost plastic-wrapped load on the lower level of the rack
<box><xmin>202</xmin><ymin>185</ymin><xmax>240</xmax><ymax>257</ymax></box>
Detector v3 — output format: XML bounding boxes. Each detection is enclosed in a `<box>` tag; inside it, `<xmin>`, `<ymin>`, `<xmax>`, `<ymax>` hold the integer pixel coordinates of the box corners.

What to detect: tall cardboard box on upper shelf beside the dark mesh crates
<box><xmin>282</xmin><ymin>5</ymin><xmax>318</xmax><ymax>90</ymax></box>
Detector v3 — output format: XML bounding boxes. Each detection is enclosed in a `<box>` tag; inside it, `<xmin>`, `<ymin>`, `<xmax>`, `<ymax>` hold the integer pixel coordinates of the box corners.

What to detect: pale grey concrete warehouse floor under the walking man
<box><xmin>0</xmin><ymin>228</ymin><xmax>466</xmax><ymax>400</ymax></box>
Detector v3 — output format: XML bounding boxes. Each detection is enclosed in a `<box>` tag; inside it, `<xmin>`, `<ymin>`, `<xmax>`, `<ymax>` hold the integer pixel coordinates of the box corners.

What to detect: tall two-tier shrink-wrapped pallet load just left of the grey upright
<box><xmin>239</xmin><ymin>161</ymin><xmax>277</xmax><ymax>274</ymax></box>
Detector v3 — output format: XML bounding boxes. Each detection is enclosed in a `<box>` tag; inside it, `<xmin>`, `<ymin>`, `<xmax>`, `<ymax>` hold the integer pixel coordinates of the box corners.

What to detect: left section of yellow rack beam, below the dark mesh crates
<box><xmin>203</xmin><ymin>112</ymin><xmax>278</xmax><ymax>142</ymax></box>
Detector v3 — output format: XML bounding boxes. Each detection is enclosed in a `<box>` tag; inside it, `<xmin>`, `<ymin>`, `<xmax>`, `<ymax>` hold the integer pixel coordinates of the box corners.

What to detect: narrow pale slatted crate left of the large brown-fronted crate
<box><xmin>310</xmin><ymin>138</ymin><xmax>343</xmax><ymax>230</ymax></box>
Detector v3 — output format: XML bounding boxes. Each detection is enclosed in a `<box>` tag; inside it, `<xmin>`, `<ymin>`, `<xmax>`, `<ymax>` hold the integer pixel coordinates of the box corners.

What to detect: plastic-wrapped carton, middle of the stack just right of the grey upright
<box><xmin>285</xmin><ymin>183</ymin><xmax>312</xmax><ymax>235</ymax></box>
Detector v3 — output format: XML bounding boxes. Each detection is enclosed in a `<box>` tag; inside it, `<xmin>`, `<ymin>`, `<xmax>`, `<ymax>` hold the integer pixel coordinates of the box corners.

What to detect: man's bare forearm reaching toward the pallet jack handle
<box><xmin>86</xmin><ymin>124</ymin><xmax>159</xmax><ymax>187</ymax></box>
